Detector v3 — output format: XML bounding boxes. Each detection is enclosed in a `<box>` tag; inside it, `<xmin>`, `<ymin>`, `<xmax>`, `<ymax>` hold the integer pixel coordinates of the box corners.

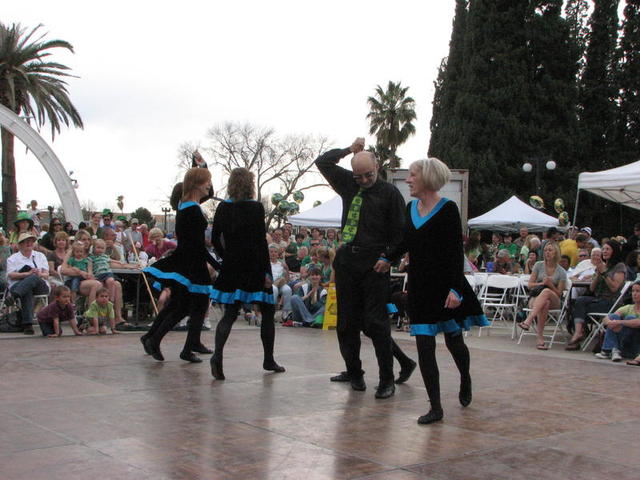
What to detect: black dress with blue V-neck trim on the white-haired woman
<box><xmin>401</xmin><ymin>197</ymin><xmax>489</xmax><ymax>336</ymax></box>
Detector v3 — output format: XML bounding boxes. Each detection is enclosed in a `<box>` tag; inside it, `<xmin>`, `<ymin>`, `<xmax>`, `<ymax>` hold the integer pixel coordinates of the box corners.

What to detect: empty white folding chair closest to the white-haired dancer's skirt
<box><xmin>478</xmin><ymin>275</ymin><xmax>520</xmax><ymax>339</ymax></box>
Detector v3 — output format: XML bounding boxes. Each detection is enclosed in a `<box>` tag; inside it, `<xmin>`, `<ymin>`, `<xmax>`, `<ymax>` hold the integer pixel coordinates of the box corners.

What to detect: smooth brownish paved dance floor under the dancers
<box><xmin>0</xmin><ymin>314</ymin><xmax>640</xmax><ymax>480</ymax></box>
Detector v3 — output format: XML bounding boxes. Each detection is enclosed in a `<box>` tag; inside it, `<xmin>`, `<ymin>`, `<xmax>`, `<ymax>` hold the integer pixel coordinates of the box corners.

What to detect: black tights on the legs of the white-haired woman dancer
<box><xmin>416</xmin><ymin>332</ymin><xmax>471</xmax><ymax>409</ymax></box>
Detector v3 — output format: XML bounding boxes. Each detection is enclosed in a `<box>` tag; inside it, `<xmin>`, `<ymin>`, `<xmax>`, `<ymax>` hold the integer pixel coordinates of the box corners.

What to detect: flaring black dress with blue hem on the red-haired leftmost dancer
<box><xmin>143</xmin><ymin>202</ymin><xmax>220</xmax><ymax>296</ymax></box>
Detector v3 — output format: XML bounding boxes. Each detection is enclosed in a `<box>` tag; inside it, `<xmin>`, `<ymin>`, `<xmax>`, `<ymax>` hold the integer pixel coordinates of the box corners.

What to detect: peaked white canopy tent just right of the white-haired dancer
<box><xmin>468</xmin><ymin>195</ymin><xmax>559</xmax><ymax>232</ymax></box>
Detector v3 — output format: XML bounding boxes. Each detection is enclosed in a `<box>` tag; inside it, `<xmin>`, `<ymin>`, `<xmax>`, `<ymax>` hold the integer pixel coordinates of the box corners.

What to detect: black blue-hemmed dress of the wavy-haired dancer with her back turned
<box><xmin>211</xmin><ymin>199</ymin><xmax>275</xmax><ymax>304</ymax></box>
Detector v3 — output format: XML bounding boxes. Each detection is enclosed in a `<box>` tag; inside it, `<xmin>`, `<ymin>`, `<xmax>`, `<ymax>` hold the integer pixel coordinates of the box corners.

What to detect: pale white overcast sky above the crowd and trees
<box><xmin>1</xmin><ymin>0</ymin><xmax>455</xmax><ymax>212</ymax></box>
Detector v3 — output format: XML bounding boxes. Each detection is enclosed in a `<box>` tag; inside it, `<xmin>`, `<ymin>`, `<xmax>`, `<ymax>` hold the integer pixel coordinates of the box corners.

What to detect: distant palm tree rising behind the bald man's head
<box><xmin>367</xmin><ymin>81</ymin><xmax>416</xmax><ymax>168</ymax></box>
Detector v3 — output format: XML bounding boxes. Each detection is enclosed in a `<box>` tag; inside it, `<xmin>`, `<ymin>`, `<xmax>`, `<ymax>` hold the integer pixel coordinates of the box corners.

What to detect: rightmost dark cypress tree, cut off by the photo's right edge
<box><xmin>616</xmin><ymin>0</ymin><xmax>640</xmax><ymax>164</ymax></box>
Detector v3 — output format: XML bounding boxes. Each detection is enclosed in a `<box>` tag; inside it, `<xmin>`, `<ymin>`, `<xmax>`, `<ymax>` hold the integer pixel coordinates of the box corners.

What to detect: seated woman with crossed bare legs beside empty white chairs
<box><xmin>518</xmin><ymin>242</ymin><xmax>567</xmax><ymax>350</ymax></box>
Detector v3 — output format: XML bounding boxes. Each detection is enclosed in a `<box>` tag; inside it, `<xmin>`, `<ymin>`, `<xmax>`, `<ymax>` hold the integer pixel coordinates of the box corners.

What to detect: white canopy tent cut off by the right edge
<box><xmin>573</xmin><ymin>160</ymin><xmax>640</xmax><ymax>221</ymax></box>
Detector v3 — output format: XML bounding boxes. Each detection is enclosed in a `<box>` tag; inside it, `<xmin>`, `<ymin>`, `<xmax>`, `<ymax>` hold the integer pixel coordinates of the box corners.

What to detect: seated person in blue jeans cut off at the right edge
<box><xmin>596</xmin><ymin>283</ymin><xmax>640</xmax><ymax>362</ymax></box>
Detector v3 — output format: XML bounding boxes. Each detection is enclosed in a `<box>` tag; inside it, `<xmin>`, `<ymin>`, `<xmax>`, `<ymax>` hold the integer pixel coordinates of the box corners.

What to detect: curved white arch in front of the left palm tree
<box><xmin>0</xmin><ymin>105</ymin><xmax>82</xmax><ymax>227</ymax></box>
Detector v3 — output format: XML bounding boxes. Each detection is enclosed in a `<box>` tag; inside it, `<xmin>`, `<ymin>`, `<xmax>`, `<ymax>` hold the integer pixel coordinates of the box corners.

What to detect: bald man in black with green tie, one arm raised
<box><xmin>316</xmin><ymin>138</ymin><xmax>416</xmax><ymax>398</ymax></box>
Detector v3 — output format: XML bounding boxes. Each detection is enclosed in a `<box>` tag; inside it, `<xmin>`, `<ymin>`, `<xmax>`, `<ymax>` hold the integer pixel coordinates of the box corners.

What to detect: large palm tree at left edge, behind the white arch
<box><xmin>0</xmin><ymin>22</ymin><xmax>83</xmax><ymax>227</ymax></box>
